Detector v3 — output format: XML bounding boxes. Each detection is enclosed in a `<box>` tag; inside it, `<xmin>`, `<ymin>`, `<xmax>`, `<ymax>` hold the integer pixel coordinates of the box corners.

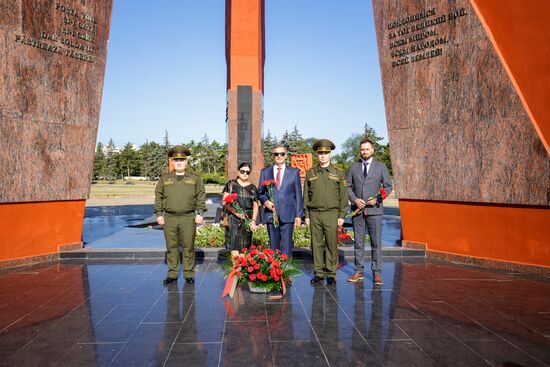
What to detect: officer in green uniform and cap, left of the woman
<box><xmin>155</xmin><ymin>145</ymin><xmax>206</xmax><ymax>284</ymax></box>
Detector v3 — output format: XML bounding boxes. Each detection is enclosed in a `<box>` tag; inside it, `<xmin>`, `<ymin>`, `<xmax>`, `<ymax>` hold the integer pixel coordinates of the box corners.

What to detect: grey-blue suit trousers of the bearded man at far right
<box><xmin>352</xmin><ymin>214</ymin><xmax>383</xmax><ymax>273</ymax></box>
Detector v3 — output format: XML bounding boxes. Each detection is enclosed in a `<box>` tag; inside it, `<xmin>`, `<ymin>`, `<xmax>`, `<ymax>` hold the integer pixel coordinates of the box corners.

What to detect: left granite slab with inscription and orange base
<box><xmin>0</xmin><ymin>0</ymin><xmax>112</xmax><ymax>263</ymax></box>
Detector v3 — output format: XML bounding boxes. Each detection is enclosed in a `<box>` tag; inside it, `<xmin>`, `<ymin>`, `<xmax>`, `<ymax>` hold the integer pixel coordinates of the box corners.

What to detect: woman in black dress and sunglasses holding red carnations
<box><xmin>223</xmin><ymin>162</ymin><xmax>259</xmax><ymax>251</ymax></box>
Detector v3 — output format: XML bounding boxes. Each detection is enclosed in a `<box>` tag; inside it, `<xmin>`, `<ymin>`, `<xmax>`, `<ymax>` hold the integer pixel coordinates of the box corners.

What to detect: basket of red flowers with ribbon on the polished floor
<box><xmin>222</xmin><ymin>245</ymin><xmax>300</xmax><ymax>298</ymax></box>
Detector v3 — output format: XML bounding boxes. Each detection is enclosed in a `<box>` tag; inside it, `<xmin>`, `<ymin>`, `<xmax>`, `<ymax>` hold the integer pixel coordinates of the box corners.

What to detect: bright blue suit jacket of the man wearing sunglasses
<box><xmin>258</xmin><ymin>165</ymin><xmax>304</xmax><ymax>223</ymax></box>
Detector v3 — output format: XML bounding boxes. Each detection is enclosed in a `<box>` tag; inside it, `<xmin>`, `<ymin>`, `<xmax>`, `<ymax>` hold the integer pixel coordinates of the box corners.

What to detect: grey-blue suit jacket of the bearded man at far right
<box><xmin>347</xmin><ymin>158</ymin><xmax>392</xmax><ymax>215</ymax></box>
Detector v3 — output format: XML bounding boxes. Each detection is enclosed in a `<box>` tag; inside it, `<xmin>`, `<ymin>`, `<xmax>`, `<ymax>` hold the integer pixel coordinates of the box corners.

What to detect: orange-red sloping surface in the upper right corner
<box><xmin>471</xmin><ymin>0</ymin><xmax>550</xmax><ymax>154</ymax></box>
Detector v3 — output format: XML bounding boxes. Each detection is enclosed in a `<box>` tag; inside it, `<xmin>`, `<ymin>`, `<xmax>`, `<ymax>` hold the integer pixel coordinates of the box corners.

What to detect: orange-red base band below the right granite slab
<box><xmin>399</xmin><ymin>199</ymin><xmax>550</xmax><ymax>267</ymax></box>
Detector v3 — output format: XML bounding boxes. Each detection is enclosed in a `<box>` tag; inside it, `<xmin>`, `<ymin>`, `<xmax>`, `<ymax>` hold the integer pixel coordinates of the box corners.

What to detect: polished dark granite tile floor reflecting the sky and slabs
<box><xmin>0</xmin><ymin>258</ymin><xmax>550</xmax><ymax>367</ymax></box>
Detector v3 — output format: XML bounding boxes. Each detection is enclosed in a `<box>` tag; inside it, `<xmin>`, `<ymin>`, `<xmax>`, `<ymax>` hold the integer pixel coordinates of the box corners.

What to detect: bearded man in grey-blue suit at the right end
<box><xmin>347</xmin><ymin>138</ymin><xmax>392</xmax><ymax>285</ymax></box>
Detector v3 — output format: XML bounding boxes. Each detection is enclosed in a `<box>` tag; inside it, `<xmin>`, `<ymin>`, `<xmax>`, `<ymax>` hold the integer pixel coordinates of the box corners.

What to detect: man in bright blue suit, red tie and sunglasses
<box><xmin>258</xmin><ymin>145</ymin><xmax>304</xmax><ymax>257</ymax></box>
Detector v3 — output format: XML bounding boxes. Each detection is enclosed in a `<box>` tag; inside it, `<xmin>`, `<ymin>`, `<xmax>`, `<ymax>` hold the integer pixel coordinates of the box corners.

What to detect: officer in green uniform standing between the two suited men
<box><xmin>304</xmin><ymin>139</ymin><xmax>348</xmax><ymax>284</ymax></box>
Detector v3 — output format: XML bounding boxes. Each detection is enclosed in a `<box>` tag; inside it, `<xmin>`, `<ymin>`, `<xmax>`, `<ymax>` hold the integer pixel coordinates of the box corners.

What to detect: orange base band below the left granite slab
<box><xmin>0</xmin><ymin>200</ymin><xmax>86</xmax><ymax>261</ymax></box>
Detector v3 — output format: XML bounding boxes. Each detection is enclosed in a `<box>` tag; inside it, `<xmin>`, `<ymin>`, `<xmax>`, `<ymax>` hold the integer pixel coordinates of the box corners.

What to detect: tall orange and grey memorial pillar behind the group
<box><xmin>225</xmin><ymin>0</ymin><xmax>265</xmax><ymax>184</ymax></box>
